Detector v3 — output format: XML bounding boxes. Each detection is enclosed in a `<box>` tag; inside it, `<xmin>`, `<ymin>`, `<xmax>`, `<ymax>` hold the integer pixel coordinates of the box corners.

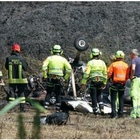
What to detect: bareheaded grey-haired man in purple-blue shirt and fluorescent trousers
<box><xmin>130</xmin><ymin>49</ymin><xmax>140</xmax><ymax>118</ymax></box>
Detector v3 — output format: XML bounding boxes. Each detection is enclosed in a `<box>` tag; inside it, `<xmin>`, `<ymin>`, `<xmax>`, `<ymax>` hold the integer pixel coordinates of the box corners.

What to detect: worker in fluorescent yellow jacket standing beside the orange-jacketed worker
<box><xmin>81</xmin><ymin>48</ymin><xmax>107</xmax><ymax>115</ymax></box>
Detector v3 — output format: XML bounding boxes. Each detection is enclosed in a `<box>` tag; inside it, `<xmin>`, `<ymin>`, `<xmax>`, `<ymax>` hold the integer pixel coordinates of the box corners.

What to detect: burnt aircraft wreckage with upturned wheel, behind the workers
<box><xmin>2</xmin><ymin>37</ymin><xmax>131</xmax><ymax>114</ymax></box>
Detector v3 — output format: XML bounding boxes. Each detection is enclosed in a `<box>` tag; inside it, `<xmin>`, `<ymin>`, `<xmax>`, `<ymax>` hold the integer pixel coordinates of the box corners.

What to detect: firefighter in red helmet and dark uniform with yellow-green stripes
<box><xmin>5</xmin><ymin>44</ymin><xmax>28</xmax><ymax>112</ymax></box>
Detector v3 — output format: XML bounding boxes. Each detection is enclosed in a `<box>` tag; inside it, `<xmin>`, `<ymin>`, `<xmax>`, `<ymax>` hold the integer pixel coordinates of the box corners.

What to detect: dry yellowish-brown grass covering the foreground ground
<box><xmin>0</xmin><ymin>106</ymin><xmax>140</xmax><ymax>139</ymax></box>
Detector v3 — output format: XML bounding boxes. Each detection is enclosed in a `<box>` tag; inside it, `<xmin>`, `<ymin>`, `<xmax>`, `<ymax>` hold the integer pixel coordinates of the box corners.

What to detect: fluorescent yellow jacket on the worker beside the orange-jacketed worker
<box><xmin>81</xmin><ymin>59</ymin><xmax>107</xmax><ymax>84</ymax></box>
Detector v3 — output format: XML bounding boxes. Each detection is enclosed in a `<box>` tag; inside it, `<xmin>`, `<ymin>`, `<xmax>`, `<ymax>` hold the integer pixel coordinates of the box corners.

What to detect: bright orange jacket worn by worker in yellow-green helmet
<box><xmin>108</xmin><ymin>60</ymin><xmax>129</xmax><ymax>83</ymax></box>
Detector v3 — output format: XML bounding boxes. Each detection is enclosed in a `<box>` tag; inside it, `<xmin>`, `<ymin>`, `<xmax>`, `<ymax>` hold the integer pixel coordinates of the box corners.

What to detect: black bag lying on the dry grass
<box><xmin>40</xmin><ymin>112</ymin><xmax>69</xmax><ymax>125</ymax></box>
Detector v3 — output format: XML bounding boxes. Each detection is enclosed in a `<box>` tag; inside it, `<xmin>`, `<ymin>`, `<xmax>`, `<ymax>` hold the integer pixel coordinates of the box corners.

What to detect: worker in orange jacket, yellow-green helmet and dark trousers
<box><xmin>108</xmin><ymin>50</ymin><xmax>129</xmax><ymax>118</ymax></box>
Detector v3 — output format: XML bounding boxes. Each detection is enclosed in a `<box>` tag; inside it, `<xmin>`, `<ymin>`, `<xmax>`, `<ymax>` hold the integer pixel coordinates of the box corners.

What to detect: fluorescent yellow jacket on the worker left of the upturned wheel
<box><xmin>42</xmin><ymin>55</ymin><xmax>72</xmax><ymax>80</ymax></box>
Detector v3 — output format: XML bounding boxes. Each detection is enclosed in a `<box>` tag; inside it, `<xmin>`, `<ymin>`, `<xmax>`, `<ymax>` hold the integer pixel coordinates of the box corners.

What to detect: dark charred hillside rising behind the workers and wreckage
<box><xmin>0</xmin><ymin>1</ymin><xmax>140</xmax><ymax>60</ymax></box>
